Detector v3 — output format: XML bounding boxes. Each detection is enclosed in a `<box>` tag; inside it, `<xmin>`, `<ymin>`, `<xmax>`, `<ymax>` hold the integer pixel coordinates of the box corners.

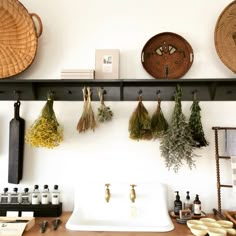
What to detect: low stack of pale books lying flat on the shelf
<box><xmin>61</xmin><ymin>69</ymin><xmax>95</xmax><ymax>79</ymax></box>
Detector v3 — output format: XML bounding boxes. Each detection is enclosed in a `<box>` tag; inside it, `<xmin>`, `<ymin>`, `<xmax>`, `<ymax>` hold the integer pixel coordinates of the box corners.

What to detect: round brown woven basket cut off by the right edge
<box><xmin>215</xmin><ymin>1</ymin><xmax>236</xmax><ymax>73</ymax></box>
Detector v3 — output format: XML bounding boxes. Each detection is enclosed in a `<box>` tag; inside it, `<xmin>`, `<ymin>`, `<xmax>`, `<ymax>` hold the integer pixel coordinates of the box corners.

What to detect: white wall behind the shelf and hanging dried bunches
<box><xmin>0</xmin><ymin>0</ymin><xmax>236</xmax><ymax>212</ymax></box>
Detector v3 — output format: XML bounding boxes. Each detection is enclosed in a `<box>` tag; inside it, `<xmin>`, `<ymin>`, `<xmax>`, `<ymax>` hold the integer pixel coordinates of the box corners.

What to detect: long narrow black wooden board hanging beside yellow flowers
<box><xmin>8</xmin><ymin>101</ymin><xmax>25</xmax><ymax>184</ymax></box>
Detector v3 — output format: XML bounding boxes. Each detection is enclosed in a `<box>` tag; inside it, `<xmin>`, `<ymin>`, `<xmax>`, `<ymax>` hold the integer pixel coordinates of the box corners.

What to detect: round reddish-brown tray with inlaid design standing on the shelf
<box><xmin>141</xmin><ymin>32</ymin><xmax>194</xmax><ymax>79</ymax></box>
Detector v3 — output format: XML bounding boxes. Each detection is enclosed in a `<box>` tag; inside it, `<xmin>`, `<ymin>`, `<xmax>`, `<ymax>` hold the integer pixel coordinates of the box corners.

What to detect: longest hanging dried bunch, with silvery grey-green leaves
<box><xmin>160</xmin><ymin>86</ymin><xmax>195</xmax><ymax>172</ymax></box>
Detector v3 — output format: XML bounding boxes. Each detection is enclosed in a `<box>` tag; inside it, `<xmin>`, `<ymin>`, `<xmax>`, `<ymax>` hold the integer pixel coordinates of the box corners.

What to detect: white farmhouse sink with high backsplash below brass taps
<box><xmin>66</xmin><ymin>183</ymin><xmax>174</xmax><ymax>232</ymax></box>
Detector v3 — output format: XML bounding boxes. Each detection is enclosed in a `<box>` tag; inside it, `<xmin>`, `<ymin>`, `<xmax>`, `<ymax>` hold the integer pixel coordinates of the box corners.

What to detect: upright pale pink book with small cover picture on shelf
<box><xmin>95</xmin><ymin>49</ymin><xmax>120</xmax><ymax>79</ymax></box>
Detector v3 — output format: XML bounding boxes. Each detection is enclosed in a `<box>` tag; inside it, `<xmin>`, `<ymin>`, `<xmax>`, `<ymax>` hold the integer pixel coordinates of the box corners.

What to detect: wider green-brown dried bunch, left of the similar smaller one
<box><xmin>129</xmin><ymin>94</ymin><xmax>152</xmax><ymax>140</ymax></box>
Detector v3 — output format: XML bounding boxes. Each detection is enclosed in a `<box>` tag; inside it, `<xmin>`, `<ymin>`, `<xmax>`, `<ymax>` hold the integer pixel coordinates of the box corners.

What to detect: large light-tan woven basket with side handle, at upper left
<box><xmin>0</xmin><ymin>0</ymin><xmax>42</xmax><ymax>79</ymax></box>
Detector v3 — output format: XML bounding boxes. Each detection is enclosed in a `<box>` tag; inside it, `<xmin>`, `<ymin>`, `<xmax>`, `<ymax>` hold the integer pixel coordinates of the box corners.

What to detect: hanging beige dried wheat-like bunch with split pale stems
<box><xmin>77</xmin><ymin>87</ymin><xmax>96</xmax><ymax>133</ymax></box>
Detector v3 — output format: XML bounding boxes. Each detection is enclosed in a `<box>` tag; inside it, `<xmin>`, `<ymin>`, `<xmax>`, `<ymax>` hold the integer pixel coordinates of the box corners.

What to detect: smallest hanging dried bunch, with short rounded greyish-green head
<box><xmin>97</xmin><ymin>88</ymin><xmax>113</xmax><ymax>122</ymax></box>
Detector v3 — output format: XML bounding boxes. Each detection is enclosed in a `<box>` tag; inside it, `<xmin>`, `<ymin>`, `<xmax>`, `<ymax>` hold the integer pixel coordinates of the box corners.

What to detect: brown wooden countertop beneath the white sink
<box><xmin>23</xmin><ymin>212</ymin><xmax>214</xmax><ymax>236</ymax></box>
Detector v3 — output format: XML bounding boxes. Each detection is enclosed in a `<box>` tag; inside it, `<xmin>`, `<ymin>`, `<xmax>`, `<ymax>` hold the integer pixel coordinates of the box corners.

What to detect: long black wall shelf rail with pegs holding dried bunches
<box><xmin>0</xmin><ymin>79</ymin><xmax>236</xmax><ymax>101</ymax></box>
